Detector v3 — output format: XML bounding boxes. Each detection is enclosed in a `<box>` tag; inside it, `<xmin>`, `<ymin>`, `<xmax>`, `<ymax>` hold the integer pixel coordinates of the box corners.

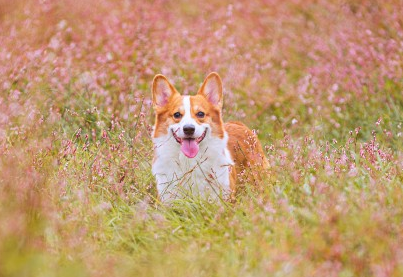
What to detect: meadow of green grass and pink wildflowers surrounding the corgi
<box><xmin>0</xmin><ymin>0</ymin><xmax>403</xmax><ymax>277</ymax></box>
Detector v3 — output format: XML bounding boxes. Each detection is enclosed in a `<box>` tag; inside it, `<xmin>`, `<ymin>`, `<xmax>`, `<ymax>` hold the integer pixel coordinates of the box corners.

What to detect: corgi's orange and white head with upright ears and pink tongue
<box><xmin>152</xmin><ymin>72</ymin><xmax>224</xmax><ymax>158</ymax></box>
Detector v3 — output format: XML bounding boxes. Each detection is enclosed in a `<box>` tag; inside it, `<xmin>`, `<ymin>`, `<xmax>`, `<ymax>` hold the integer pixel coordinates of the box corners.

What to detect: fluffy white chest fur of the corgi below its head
<box><xmin>152</xmin><ymin>133</ymin><xmax>233</xmax><ymax>202</ymax></box>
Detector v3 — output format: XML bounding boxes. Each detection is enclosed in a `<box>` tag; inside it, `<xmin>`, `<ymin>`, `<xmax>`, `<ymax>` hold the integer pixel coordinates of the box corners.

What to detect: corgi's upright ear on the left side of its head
<box><xmin>152</xmin><ymin>74</ymin><xmax>178</xmax><ymax>108</ymax></box>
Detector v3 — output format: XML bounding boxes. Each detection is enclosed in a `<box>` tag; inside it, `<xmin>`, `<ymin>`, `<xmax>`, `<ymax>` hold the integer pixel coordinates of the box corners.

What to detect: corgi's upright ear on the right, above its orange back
<box><xmin>197</xmin><ymin>72</ymin><xmax>223</xmax><ymax>110</ymax></box>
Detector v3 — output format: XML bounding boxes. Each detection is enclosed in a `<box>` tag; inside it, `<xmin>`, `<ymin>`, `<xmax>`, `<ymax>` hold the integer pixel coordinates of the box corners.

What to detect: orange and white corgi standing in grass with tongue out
<box><xmin>152</xmin><ymin>72</ymin><xmax>268</xmax><ymax>202</ymax></box>
